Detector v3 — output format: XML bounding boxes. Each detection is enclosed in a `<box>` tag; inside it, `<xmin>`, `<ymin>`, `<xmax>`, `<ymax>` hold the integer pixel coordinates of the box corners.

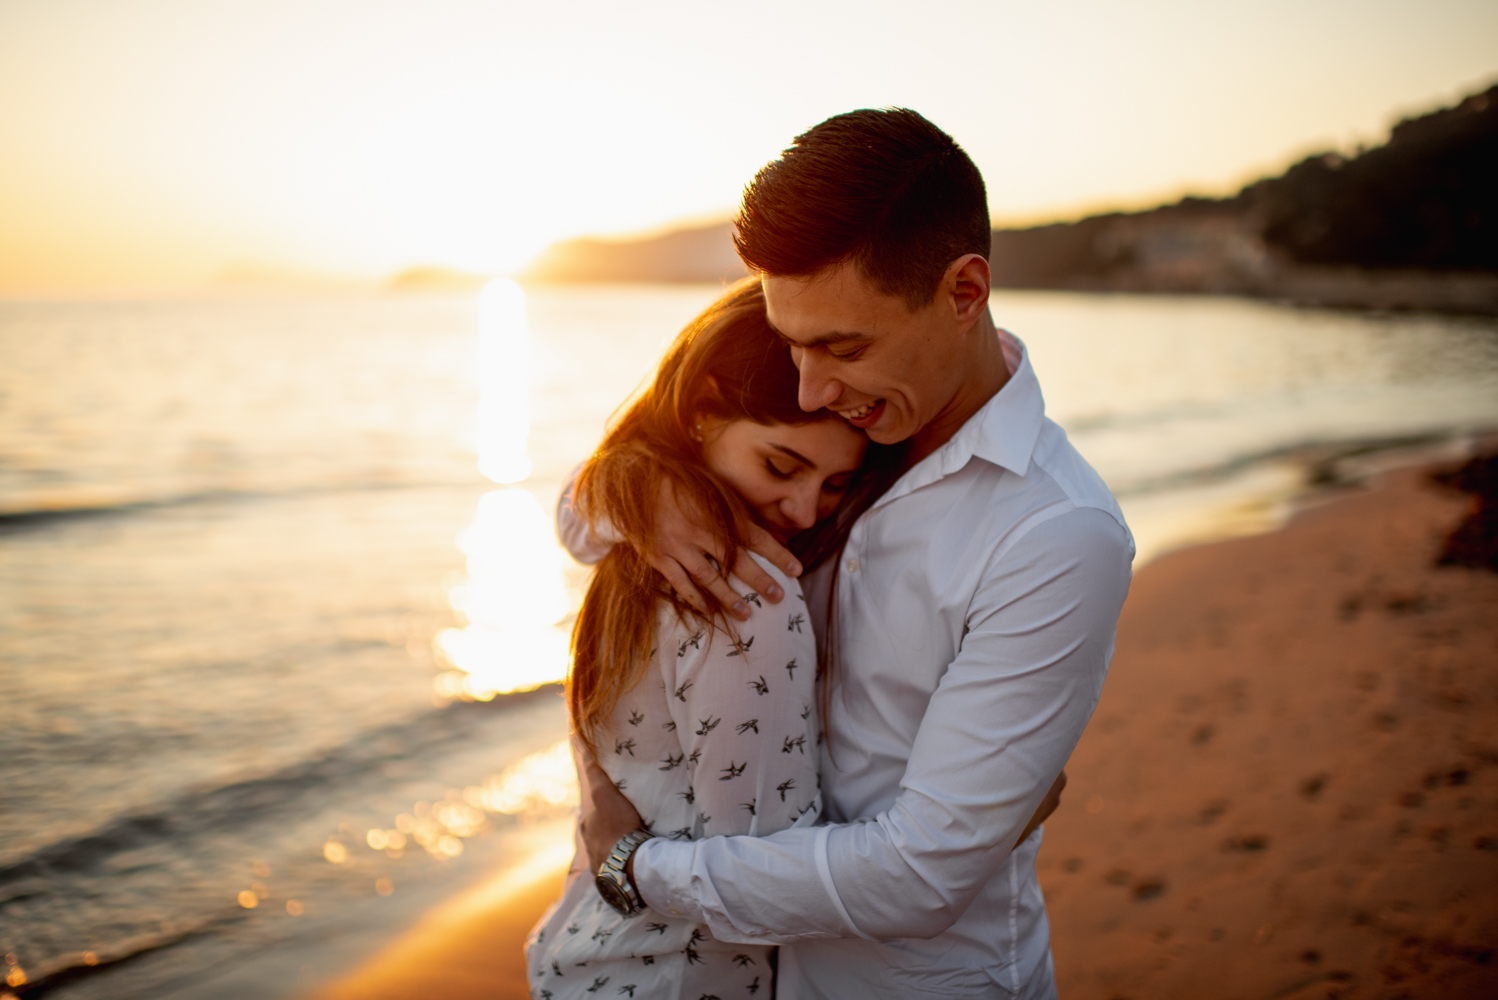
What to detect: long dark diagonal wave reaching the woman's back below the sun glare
<box><xmin>0</xmin><ymin>684</ymin><xmax>556</xmax><ymax>886</ymax></box>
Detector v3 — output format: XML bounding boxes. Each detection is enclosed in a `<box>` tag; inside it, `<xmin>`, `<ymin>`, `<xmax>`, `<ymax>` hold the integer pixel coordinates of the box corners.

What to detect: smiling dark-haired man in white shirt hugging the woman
<box><xmin>560</xmin><ymin>109</ymin><xmax>1132</xmax><ymax>1000</ymax></box>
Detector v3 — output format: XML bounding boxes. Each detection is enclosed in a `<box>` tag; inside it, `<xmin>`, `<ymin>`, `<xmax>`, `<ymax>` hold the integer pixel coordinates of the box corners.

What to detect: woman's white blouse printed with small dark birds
<box><xmin>526</xmin><ymin>557</ymin><xmax>821</xmax><ymax>1000</ymax></box>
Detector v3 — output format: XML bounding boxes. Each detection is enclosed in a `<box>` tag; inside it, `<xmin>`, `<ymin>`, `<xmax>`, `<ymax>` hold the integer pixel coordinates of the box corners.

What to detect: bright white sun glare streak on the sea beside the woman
<box><xmin>434</xmin><ymin>278</ymin><xmax>568</xmax><ymax>701</ymax></box>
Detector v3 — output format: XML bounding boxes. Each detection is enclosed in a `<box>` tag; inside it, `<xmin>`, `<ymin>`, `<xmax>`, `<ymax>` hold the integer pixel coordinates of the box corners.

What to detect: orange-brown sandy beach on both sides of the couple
<box><xmin>307</xmin><ymin>458</ymin><xmax>1498</xmax><ymax>1000</ymax></box>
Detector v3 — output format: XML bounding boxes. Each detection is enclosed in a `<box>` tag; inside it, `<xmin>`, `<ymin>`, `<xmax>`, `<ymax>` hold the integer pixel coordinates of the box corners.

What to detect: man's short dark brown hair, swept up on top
<box><xmin>734</xmin><ymin>108</ymin><xmax>993</xmax><ymax>308</ymax></box>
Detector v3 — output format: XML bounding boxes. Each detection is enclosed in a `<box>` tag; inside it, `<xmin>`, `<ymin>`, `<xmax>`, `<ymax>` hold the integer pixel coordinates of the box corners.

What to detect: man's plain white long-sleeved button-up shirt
<box><xmin>557</xmin><ymin>331</ymin><xmax>1134</xmax><ymax>1000</ymax></box>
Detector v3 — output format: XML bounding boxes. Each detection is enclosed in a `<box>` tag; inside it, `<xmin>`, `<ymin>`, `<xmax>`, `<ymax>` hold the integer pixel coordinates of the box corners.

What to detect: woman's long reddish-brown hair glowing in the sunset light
<box><xmin>566</xmin><ymin>278</ymin><xmax>897</xmax><ymax>750</ymax></box>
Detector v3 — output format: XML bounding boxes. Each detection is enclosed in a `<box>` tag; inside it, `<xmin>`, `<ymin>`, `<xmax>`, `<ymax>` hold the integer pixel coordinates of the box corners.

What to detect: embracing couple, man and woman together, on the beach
<box><xmin>526</xmin><ymin>109</ymin><xmax>1132</xmax><ymax>1000</ymax></box>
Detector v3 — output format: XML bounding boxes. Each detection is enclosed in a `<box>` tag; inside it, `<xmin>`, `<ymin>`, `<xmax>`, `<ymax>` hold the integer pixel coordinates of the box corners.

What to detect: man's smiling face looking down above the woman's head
<box><xmin>762</xmin><ymin>257</ymin><xmax>971</xmax><ymax>445</ymax></box>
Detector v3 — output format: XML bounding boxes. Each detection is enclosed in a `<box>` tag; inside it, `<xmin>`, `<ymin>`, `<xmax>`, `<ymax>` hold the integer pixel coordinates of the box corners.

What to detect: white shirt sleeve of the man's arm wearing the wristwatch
<box><xmin>634</xmin><ymin>509</ymin><xmax>1129</xmax><ymax>943</ymax></box>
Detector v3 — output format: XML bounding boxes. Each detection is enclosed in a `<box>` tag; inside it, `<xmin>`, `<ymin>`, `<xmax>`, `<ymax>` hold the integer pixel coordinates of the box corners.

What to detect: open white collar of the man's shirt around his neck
<box><xmin>875</xmin><ymin>329</ymin><xmax>1046</xmax><ymax>506</ymax></box>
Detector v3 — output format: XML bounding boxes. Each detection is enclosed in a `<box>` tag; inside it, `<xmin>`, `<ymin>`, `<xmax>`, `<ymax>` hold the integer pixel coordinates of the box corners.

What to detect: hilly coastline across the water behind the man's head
<box><xmin>524</xmin><ymin>85</ymin><xmax>1498</xmax><ymax>314</ymax></box>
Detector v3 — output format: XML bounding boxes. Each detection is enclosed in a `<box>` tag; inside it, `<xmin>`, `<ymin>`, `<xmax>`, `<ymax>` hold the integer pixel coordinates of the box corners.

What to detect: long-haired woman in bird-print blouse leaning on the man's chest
<box><xmin>526</xmin><ymin>281</ymin><xmax>894</xmax><ymax>1000</ymax></box>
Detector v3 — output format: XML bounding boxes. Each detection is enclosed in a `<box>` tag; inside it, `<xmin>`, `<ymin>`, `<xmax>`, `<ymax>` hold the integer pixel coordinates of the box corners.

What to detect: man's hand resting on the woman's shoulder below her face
<box><xmin>650</xmin><ymin>478</ymin><xmax>801</xmax><ymax>616</ymax></box>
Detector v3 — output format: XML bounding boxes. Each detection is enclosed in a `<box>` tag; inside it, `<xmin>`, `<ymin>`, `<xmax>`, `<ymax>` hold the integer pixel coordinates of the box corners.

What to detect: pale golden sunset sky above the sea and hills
<box><xmin>0</xmin><ymin>0</ymin><xmax>1498</xmax><ymax>295</ymax></box>
